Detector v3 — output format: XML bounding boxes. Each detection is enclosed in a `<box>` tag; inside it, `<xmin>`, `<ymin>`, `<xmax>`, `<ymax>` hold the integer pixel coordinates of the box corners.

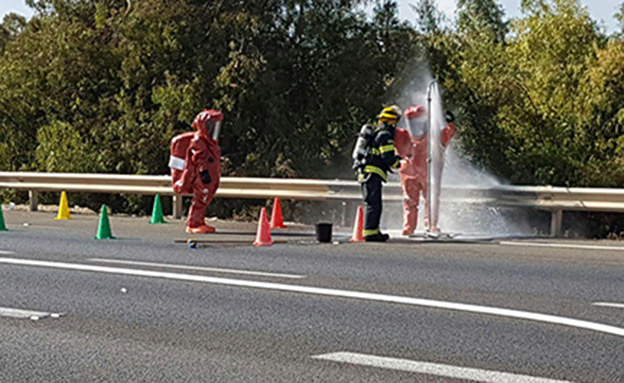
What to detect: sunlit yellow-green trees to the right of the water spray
<box><xmin>444</xmin><ymin>0</ymin><xmax>624</xmax><ymax>186</ymax></box>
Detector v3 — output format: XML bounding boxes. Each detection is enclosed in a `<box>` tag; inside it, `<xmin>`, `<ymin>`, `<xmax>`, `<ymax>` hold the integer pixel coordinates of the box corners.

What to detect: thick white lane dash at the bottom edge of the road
<box><xmin>312</xmin><ymin>352</ymin><xmax>571</xmax><ymax>383</ymax></box>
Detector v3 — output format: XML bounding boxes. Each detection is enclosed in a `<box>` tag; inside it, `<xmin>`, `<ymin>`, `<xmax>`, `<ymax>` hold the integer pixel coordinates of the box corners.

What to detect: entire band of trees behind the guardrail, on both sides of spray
<box><xmin>0</xmin><ymin>0</ymin><xmax>624</xmax><ymax>210</ymax></box>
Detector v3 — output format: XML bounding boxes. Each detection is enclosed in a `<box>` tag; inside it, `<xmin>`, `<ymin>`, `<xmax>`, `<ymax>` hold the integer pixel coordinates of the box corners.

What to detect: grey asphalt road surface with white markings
<box><xmin>0</xmin><ymin>211</ymin><xmax>624</xmax><ymax>383</ymax></box>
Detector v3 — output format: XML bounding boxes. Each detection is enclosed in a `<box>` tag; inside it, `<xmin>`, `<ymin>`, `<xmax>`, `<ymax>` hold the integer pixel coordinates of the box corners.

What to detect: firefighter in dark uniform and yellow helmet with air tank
<box><xmin>358</xmin><ymin>106</ymin><xmax>401</xmax><ymax>242</ymax></box>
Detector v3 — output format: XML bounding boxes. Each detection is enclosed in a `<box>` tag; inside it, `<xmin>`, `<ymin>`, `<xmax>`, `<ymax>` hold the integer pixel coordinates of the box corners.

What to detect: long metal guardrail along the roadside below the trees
<box><xmin>0</xmin><ymin>172</ymin><xmax>624</xmax><ymax>236</ymax></box>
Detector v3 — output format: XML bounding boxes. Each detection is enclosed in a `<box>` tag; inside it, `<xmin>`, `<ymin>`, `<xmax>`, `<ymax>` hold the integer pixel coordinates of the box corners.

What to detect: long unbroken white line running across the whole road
<box><xmin>0</xmin><ymin>258</ymin><xmax>624</xmax><ymax>337</ymax></box>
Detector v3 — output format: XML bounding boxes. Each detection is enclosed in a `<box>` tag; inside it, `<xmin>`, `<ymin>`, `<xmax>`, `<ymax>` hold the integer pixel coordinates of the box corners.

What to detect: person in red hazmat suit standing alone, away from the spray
<box><xmin>169</xmin><ymin>110</ymin><xmax>223</xmax><ymax>234</ymax></box>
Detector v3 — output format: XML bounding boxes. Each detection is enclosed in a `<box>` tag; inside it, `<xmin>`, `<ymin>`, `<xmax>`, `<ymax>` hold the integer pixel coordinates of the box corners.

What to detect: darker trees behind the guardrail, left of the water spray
<box><xmin>0</xmin><ymin>0</ymin><xmax>415</xmax><ymax>184</ymax></box>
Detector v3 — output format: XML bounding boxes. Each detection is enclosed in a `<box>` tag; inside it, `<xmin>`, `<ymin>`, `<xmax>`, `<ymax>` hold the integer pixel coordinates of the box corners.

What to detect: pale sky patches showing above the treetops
<box><xmin>0</xmin><ymin>0</ymin><xmax>624</xmax><ymax>33</ymax></box>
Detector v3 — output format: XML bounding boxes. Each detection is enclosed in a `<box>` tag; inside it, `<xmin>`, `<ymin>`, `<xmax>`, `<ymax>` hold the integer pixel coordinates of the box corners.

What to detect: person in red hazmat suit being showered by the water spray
<box><xmin>394</xmin><ymin>105</ymin><xmax>456</xmax><ymax>235</ymax></box>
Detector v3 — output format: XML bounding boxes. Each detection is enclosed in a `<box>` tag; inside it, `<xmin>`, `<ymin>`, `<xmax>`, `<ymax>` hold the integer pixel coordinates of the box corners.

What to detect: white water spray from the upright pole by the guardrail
<box><xmin>383</xmin><ymin>70</ymin><xmax>533</xmax><ymax>236</ymax></box>
